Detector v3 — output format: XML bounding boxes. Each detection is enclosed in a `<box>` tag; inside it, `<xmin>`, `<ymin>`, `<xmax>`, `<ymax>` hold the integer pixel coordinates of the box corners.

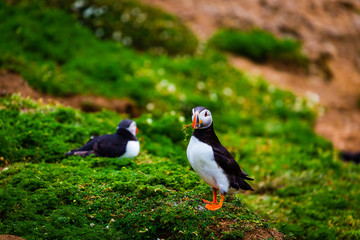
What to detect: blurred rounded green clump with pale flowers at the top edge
<box><xmin>9</xmin><ymin>0</ymin><xmax>198</xmax><ymax>55</ymax></box>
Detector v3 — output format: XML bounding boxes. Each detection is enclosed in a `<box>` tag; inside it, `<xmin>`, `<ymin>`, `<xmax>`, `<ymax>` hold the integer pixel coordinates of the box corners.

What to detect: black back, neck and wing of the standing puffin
<box><xmin>193</xmin><ymin>124</ymin><xmax>254</xmax><ymax>190</ymax></box>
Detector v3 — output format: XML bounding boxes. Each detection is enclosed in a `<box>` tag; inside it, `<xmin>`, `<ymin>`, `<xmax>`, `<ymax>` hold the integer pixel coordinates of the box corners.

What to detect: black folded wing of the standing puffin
<box><xmin>212</xmin><ymin>144</ymin><xmax>254</xmax><ymax>190</ymax></box>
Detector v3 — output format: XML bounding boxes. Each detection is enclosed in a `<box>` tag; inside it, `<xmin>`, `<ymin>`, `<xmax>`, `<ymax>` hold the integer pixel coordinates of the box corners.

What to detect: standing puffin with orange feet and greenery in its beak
<box><xmin>186</xmin><ymin>106</ymin><xmax>254</xmax><ymax>211</ymax></box>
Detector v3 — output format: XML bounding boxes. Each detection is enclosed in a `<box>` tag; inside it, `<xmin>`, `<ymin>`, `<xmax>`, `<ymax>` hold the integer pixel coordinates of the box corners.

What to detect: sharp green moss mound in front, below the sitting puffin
<box><xmin>0</xmin><ymin>146</ymin><xmax>268</xmax><ymax>239</ymax></box>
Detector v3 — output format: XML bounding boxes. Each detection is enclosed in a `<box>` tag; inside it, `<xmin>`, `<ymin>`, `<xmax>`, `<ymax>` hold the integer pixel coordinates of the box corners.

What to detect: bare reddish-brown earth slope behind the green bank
<box><xmin>146</xmin><ymin>0</ymin><xmax>360</xmax><ymax>151</ymax></box>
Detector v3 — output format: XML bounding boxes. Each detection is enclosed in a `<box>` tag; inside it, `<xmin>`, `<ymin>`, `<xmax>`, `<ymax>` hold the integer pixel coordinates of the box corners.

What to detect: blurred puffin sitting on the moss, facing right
<box><xmin>65</xmin><ymin>119</ymin><xmax>140</xmax><ymax>158</ymax></box>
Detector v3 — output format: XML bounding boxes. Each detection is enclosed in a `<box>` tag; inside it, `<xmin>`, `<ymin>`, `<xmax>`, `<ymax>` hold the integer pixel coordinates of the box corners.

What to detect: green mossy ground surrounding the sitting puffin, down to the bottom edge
<box><xmin>0</xmin><ymin>95</ymin><xmax>278</xmax><ymax>239</ymax></box>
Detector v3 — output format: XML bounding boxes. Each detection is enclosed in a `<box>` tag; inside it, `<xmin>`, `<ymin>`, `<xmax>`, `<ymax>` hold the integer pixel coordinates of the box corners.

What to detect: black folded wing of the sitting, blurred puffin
<box><xmin>94</xmin><ymin>134</ymin><xmax>128</xmax><ymax>157</ymax></box>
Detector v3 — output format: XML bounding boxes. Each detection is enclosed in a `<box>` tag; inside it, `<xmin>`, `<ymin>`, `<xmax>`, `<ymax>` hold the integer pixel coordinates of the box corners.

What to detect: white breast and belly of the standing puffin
<box><xmin>186</xmin><ymin>136</ymin><xmax>229</xmax><ymax>192</ymax></box>
